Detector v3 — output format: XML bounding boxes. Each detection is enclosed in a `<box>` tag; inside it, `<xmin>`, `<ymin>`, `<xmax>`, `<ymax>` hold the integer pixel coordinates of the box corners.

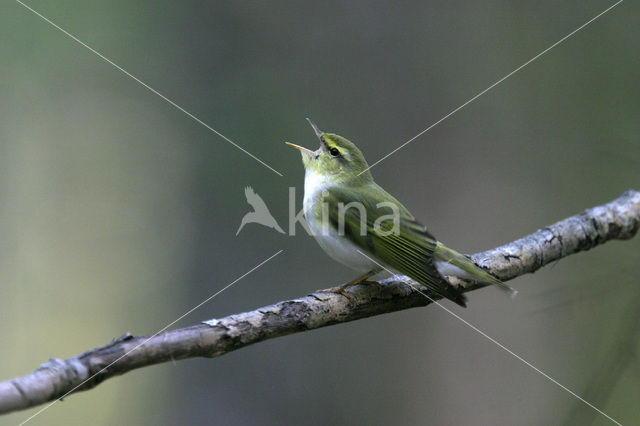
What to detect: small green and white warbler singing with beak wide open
<box><xmin>286</xmin><ymin>119</ymin><xmax>510</xmax><ymax>306</ymax></box>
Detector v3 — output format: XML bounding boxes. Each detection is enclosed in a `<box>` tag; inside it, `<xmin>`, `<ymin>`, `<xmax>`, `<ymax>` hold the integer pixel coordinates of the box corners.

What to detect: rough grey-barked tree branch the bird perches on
<box><xmin>0</xmin><ymin>191</ymin><xmax>640</xmax><ymax>413</ymax></box>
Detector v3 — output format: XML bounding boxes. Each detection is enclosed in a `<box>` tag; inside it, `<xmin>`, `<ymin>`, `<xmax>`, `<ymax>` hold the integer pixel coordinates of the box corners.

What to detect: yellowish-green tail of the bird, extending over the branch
<box><xmin>433</xmin><ymin>242</ymin><xmax>517</xmax><ymax>296</ymax></box>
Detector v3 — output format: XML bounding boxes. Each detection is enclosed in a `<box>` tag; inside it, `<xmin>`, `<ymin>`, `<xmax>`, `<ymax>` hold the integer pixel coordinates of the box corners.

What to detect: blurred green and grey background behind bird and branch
<box><xmin>0</xmin><ymin>1</ymin><xmax>640</xmax><ymax>425</ymax></box>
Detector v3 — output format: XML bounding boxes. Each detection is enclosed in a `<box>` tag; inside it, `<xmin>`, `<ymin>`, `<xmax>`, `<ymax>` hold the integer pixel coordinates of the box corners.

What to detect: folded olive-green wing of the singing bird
<box><xmin>319</xmin><ymin>183</ymin><xmax>466</xmax><ymax>306</ymax></box>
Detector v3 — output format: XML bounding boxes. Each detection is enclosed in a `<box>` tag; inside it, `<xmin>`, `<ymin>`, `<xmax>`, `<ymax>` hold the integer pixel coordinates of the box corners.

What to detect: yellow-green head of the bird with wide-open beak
<box><xmin>286</xmin><ymin>119</ymin><xmax>372</xmax><ymax>182</ymax></box>
